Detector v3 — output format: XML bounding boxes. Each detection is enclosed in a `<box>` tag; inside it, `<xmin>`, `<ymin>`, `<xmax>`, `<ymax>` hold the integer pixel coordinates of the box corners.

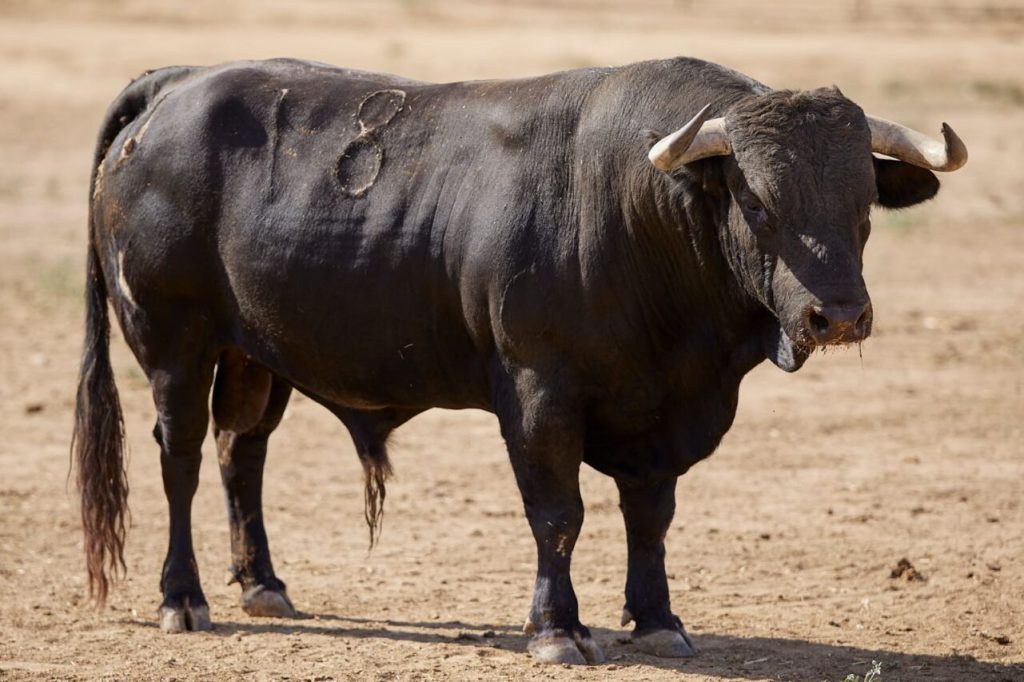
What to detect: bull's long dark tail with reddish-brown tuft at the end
<box><xmin>71</xmin><ymin>68</ymin><xmax>189</xmax><ymax>603</ymax></box>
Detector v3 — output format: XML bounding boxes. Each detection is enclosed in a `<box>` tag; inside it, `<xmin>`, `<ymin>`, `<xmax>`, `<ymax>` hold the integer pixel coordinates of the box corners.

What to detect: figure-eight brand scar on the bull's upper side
<box><xmin>336</xmin><ymin>90</ymin><xmax>406</xmax><ymax>197</ymax></box>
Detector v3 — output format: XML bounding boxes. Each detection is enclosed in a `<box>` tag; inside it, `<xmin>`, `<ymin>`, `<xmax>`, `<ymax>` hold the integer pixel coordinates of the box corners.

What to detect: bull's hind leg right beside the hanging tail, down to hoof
<box><xmin>150</xmin><ymin>358</ymin><xmax>213</xmax><ymax>632</ymax></box>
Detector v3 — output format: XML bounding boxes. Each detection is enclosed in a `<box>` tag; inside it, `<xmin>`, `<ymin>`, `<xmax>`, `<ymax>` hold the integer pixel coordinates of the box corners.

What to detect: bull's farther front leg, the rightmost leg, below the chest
<box><xmin>615</xmin><ymin>477</ymin><xmax>696</xmax><ymax>657</ymax></box>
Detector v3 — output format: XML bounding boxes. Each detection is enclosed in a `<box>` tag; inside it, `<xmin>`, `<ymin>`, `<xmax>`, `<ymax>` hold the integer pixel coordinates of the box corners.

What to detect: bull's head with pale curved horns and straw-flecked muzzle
<box><xmin>648</xmin><ymin>88</ymin><xmax>967</xmax><ymax>372</ymax></box>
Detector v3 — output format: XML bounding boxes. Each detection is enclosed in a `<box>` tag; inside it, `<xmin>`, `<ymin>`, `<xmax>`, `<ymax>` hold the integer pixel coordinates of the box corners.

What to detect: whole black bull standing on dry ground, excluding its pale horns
<box><xmin>73</xmin><ymin>59</ymin><xmax>962</xmax><ymax>663</ymax></box>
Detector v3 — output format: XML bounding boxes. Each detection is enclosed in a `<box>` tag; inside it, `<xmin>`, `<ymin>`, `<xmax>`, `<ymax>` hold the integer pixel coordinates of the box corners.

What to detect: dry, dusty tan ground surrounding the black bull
<box><xmin>0</xmin><ymin>0</ymin><xmax>1024</xmax><ymax>682</ymax></box>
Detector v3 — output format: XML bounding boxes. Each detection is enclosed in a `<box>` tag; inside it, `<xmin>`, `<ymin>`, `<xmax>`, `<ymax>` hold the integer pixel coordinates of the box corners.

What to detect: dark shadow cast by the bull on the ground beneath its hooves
<box><xmin>163</xmin><ymin>613</ymin><xmax>1024</xmax><ymax>682</ymax></box>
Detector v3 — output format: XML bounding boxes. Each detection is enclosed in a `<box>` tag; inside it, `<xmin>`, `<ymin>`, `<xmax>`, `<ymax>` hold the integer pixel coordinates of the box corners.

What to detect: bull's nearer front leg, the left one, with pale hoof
<box><xmin>498</xmin><ymin>377</ymin><xmax>604</xmax><ymax>664</ymax></box>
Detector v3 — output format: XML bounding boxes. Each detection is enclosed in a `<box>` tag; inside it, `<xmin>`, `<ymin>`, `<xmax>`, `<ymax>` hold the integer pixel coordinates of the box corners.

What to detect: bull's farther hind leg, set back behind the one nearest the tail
<box><xmin>214</xmin><ymin>378</ymin><xmax>296</xmax><ymax>617</ymax></box>
